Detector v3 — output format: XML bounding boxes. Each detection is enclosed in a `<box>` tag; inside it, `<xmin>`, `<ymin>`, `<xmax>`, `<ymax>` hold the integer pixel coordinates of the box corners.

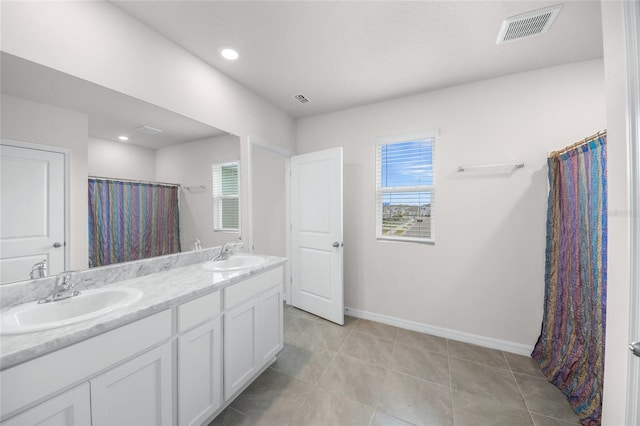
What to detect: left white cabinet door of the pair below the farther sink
<box><xmin>224</xmin><ymin>298</ymin><xmax>257</xmax><ymax>399</ymax></box>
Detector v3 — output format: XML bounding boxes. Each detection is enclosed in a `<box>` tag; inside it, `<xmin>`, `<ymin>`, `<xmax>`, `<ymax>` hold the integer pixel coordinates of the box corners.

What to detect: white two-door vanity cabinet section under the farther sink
<box><xmin>224</xmin><ymin>268</ymin><xmax>283</xmax><ymax>399</ymax></box>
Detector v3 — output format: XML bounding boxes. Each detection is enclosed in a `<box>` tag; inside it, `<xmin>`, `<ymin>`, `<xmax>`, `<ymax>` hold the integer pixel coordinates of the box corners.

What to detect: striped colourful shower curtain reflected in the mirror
<box><xmin>89</xmin><ymin>178</ymin><xmax>180</xmax><ymax>267</ymax></box>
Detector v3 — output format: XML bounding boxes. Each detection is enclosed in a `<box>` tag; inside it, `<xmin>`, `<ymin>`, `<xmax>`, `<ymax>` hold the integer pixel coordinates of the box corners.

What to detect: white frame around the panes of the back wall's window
<box><xmin>375</xmin><ymin>135</ymin><xmax>438</xmax><ymax>245</ymax></box>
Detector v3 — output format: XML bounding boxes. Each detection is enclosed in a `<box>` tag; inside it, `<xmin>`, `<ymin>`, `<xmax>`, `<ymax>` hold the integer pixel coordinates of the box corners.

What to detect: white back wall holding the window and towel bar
<box><xmin>298</xmin><ymin>61</ymin><xmax>606</xmax><ymax>352</ymax></box>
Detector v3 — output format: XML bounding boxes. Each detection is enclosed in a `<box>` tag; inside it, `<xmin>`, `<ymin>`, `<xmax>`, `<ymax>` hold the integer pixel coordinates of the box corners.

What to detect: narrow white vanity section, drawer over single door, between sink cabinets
<box><xmin>178</xmin><ymin>292</ymin><xmax>222</xmax><ymax>426</ymax></box>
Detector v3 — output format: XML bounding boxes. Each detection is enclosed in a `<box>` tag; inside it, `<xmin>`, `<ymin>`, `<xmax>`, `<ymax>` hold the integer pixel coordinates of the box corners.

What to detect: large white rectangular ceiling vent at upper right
<box><xmin>496</xmin><ymin>4</ymin><xmax>562</xmax><ymax>44</ymax></box>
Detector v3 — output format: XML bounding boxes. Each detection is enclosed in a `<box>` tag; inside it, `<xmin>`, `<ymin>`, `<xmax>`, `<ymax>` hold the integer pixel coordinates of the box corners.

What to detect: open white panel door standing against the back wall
<box><xmin>291</xmin><ymin>147</ymin><xmax>344</xmax><ymax>325</ymax></box>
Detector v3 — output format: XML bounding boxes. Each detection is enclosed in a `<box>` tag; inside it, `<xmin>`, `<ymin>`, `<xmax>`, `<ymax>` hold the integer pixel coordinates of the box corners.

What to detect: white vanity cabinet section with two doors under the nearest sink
<box><xmin>0</xmin><ymin>310</ymin><xmax>173</xmax><ymax>426</ymax></box>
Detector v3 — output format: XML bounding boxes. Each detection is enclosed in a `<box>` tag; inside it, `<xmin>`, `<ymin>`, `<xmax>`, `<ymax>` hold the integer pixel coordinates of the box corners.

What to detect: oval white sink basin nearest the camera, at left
<box><xmin>0</xmin><ymin>287</ymin><xmax>142</xmax><ymax>334</ymax></box>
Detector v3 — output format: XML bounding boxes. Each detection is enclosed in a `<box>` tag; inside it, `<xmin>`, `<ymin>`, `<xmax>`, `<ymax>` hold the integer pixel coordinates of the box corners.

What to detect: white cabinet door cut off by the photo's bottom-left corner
<box><xmin>2</xmin><ymin>383</ymin><xmax>91</xmax><ymax>426</ymax></box>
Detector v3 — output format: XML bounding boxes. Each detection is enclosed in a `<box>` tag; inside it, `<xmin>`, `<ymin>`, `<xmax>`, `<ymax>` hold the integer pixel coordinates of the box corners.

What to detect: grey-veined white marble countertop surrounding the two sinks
<box><xmin>0</xmin><ymin>256</ymin><xmax>287</xmax><ymax>370</ymax></box>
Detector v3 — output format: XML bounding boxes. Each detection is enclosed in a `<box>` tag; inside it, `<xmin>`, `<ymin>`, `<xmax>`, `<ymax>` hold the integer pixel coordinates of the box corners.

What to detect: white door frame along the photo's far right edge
<box><xmin>622</xmin><ymin>2</ymin><xmax>640</xmax><ymax>424</ymax></box>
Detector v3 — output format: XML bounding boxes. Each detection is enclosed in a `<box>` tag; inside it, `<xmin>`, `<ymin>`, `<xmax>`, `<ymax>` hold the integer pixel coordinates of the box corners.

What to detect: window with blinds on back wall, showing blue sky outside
<box><xmin>376</xmin><ymin>137</ymin><xmax>435</xmax><ymax>243</ymax></box>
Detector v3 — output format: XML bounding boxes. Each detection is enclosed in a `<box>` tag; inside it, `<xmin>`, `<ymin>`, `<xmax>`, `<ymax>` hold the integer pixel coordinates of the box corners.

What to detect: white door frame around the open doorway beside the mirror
<box><xmin>246</xmin><ymin>135</ymin><xmax>296</xmax><ymax>304</ymax></box>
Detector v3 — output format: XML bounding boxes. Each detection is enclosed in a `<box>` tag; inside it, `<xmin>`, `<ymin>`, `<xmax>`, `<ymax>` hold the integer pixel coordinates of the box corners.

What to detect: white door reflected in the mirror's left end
<box><xmin>0</xmin><ymin>141</ymin><xmax>65</xmax><ymax>283</ymax></box>
